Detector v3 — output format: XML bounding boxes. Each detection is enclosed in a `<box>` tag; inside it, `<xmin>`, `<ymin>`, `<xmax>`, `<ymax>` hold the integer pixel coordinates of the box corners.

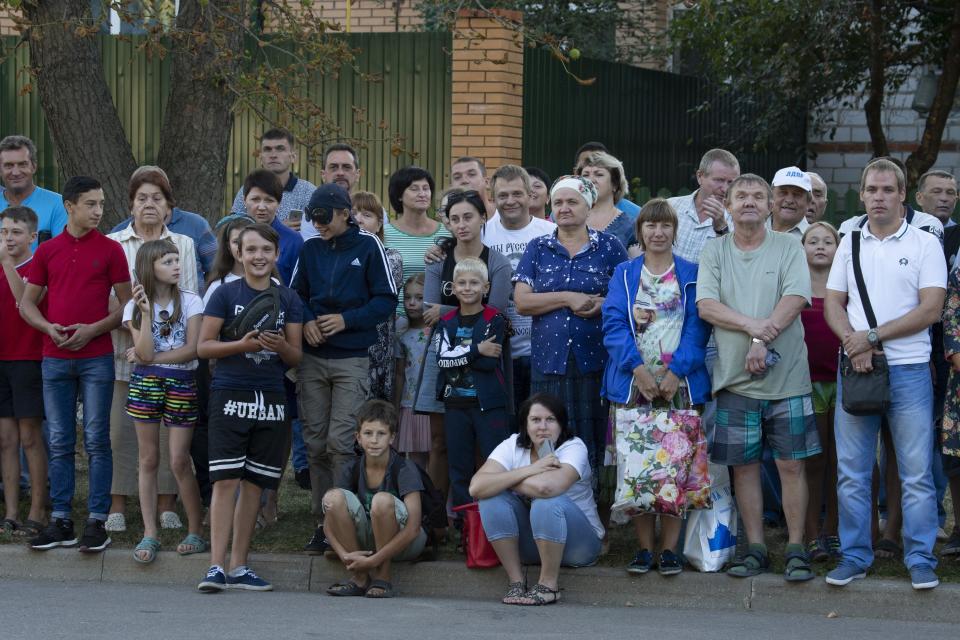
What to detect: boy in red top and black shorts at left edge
<box><xmin>0</xmin><ymin>207</ymin><xmax>47</xmax><ymax>536</ymax></box>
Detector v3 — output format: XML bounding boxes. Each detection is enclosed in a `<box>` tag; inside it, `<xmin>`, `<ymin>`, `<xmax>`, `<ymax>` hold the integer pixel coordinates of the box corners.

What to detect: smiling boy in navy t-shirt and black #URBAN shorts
<box><xmin>197</xmin><ymin>224</ymin><xmax>303</xmax><ymax>593</ymax></box>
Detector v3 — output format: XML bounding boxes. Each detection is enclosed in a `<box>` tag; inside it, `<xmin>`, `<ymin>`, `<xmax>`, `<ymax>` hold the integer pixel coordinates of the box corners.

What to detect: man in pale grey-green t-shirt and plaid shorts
<box><xmin>697</xmin><ymin>174</ymin><xmax>821</xmax><ymax>581</ymax></box>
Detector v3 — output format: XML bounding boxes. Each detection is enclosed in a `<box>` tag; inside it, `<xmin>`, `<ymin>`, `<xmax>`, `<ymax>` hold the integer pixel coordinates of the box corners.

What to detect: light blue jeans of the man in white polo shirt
<box><xmin>834</xmin><ymin>363</ymin><xmax>937</xmax><ymax>570</ymax></box>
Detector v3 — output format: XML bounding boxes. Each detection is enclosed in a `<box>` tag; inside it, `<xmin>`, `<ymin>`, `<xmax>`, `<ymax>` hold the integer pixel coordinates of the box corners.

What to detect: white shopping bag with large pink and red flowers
<box><xmin>610</xmin><ymin>405</ymin><xmax>712</xmax><ymax>524</ymax></box>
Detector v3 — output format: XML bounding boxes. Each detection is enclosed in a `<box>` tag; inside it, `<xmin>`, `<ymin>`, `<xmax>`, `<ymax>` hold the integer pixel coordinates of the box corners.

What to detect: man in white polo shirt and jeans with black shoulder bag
<box><xmin>824</xmin><ymin>159</ymin><xmax>947</xmax><ymax>589</ymax></box>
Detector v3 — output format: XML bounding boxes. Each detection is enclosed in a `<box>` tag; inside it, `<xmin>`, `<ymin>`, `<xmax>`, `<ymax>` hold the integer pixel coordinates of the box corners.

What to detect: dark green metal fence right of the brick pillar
<box><xmin>523</xmin><ymin>48</ymin><xmax>805</xmax><ymax>204</ymax></box>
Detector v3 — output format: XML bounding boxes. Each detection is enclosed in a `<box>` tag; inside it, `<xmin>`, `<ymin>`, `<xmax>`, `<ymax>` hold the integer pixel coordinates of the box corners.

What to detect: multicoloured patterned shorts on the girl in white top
<box><xmin>127</xmin><ymin>367</ymin><xmax>199</xmax><ymax>427</ymax></box>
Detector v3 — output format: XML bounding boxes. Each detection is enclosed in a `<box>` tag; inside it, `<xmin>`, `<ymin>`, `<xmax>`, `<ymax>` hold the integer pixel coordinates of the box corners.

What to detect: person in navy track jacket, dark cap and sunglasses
<box><xmin>292</xmin><ymin>183</ymin><xmax>397</xmax><ymax>555</ymax></box>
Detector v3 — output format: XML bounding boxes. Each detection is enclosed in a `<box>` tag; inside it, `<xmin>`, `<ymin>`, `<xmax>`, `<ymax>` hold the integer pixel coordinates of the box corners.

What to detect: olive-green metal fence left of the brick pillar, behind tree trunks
<box><xmin>0</xmin><ymin>33</ymin><xmax>452</xmax><ymax>212</ymax></box>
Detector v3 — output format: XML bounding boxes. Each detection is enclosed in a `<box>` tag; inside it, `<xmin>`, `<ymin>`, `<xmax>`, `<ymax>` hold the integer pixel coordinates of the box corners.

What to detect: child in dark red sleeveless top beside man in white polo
<box><xmin>800</xmin><ymin>222</ymin><xmax>840</xmax><ymax>562</ymax></box>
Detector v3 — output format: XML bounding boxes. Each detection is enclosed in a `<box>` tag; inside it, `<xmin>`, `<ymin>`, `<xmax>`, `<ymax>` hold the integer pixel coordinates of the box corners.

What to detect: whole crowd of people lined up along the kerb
<box><xmin>0</xmin><ymin>129</ymin><xmax>960</xmax><ymax>605</ymax></box>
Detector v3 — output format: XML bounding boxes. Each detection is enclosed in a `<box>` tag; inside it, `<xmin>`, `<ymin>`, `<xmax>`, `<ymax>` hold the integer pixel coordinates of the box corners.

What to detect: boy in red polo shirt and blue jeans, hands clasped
<box><xmin>20</xmin><ymin>176</ymin><xmax>131</xmax><ymax>552</ymax></box>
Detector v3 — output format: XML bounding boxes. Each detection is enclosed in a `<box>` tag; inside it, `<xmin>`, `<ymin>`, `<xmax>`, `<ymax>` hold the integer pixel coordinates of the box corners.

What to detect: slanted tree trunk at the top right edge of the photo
<box><xmin>906</xmin><ymin>4</ymin><xmax>960</xmax><ymax>187</ymax></box>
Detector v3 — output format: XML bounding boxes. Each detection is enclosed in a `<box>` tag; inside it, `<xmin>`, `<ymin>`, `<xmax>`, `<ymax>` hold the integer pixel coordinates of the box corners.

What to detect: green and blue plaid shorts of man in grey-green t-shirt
<box><xmin>710</xmin><ymin>391</ymin><xmax>822</xmax><ymax>466</ymax></box>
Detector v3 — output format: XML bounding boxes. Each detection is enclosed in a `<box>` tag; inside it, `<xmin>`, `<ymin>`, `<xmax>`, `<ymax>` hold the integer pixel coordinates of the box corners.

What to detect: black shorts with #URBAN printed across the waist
<box><xmin>208</xmin><ymin>389</ymin><xmax>290</xmax><ymax>489</ymax></box>
